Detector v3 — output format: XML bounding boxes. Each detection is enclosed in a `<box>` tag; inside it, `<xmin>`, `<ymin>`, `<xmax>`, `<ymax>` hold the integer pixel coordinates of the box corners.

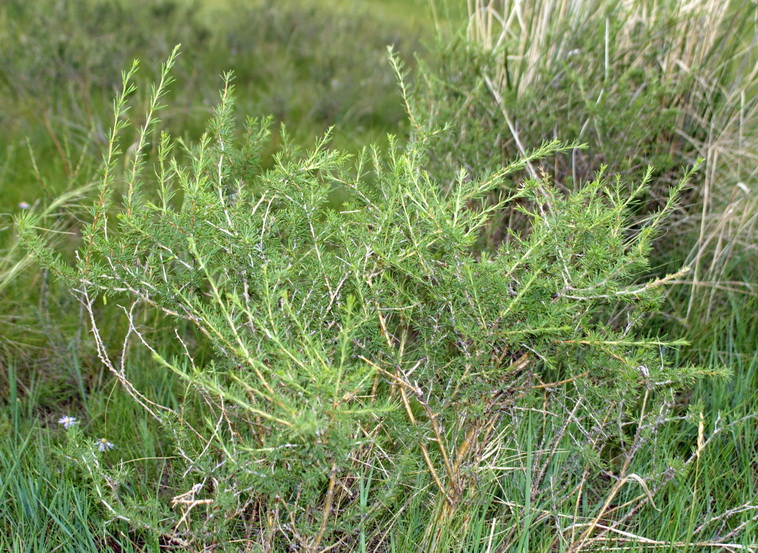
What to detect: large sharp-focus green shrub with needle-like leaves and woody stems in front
<box><xmin>18</xmin><ymin>50</ymin><xmax>723</xmax><ymax>551</ymax></box>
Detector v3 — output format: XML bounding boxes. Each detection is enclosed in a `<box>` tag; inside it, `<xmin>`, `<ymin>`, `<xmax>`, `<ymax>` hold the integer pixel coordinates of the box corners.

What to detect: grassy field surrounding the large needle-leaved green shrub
<box><xmin>0</xmin><ymin>0</ymin><xmax>758</xmax><ymax>553</ymax></box>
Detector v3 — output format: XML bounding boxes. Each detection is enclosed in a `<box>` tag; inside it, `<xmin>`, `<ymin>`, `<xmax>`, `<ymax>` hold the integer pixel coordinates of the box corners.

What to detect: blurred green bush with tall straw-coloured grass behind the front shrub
<box><xmin>419</xmin><ymin>0</ymin><xmax>758</xmax><ymax>306</ymax></box>
